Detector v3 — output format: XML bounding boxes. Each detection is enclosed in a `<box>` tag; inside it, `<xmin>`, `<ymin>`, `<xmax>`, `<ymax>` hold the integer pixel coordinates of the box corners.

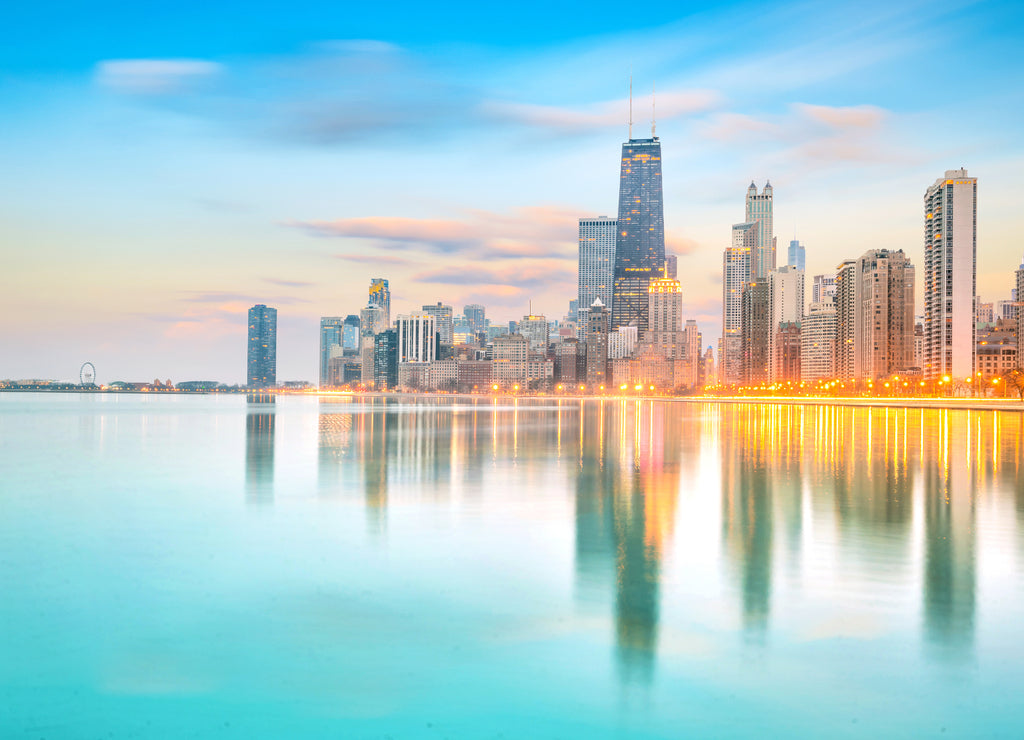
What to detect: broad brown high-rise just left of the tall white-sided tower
<box><xmin>854</xmin><ymin>250</ymin><xmax>913</xmax><ymax>380</ymax></box>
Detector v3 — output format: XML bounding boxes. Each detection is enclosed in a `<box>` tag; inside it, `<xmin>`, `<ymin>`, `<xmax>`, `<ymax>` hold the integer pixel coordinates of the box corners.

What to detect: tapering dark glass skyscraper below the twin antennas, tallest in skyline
<box><xmin>611</xmin><ymin>136</ymin><xmax>665</xmax><ymax>332</ymax></box>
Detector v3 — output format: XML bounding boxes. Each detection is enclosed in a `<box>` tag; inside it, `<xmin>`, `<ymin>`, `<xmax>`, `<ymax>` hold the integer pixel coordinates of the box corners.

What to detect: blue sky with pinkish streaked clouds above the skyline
<box><xmin>0</xmin><ymin>0</ymin><xmax>1024</xmax><ymax>383</ymax></box>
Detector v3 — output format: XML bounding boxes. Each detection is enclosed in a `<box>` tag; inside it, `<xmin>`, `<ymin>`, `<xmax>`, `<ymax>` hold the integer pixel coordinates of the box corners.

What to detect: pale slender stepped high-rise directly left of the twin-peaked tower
<box><xmin>718</xmin><ymin>223</ymin><xmax>757</xmax><ymax>385</ymax></box>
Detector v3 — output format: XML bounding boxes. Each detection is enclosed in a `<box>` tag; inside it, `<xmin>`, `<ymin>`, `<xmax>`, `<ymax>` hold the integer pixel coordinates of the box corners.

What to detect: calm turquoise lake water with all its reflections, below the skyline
<box><xmin>0</xmin><ymin>393</ymin><xmax>1024</xmax><ymax>738</ymax></box>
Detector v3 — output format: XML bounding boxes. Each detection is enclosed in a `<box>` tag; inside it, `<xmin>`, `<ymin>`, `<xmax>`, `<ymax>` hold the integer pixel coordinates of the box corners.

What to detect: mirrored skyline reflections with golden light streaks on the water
<box><xmin>307</xmin><ymin>398</ymin><xmax>1024</xmax><ymax>683</ymax></box>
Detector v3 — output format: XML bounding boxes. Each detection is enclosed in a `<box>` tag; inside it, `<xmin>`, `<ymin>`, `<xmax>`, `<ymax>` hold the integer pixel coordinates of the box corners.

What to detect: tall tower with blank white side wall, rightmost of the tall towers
<box><xmin>924</xmin><ymin>169</ymin><xmax>978</xmax><ymax>380</ymax></box>
